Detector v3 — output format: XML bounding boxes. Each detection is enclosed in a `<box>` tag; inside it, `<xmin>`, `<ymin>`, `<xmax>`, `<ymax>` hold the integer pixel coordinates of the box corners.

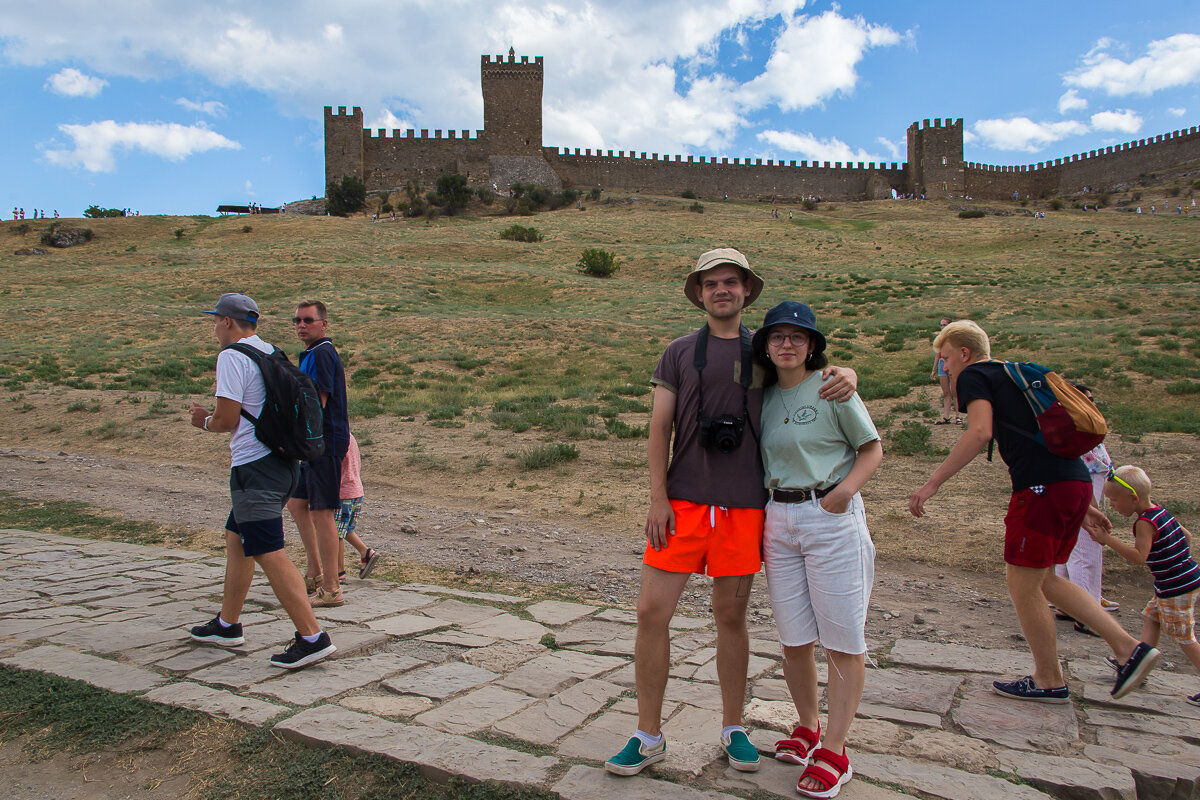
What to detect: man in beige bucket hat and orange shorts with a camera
<box><xmin>605</xmin><ymin>247</ymin><xmax>858</xmax><ymax>775</ymax></box>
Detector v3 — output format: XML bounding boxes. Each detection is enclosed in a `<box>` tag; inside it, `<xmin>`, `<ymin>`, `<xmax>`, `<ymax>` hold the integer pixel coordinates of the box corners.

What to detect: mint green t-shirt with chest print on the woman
<box><xmin>761</xmin><ymin>372</ymin><xmax>880</xmax><ymax>489</ymax></box>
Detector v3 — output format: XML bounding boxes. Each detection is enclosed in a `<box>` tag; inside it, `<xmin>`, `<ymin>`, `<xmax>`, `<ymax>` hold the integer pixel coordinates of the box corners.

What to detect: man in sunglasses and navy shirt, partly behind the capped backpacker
<box><xmin>288</xmin><ymin>300</ymin><xmax>350</xmax><ymax>608</ymax></box>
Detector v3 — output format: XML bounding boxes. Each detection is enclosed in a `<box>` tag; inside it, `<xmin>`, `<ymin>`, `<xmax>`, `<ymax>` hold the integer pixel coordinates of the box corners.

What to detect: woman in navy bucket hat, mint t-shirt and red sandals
<box><xmin>754</xmin><ymin>301</ymin><xmax>883</xmax><ymax>798</ymax></box>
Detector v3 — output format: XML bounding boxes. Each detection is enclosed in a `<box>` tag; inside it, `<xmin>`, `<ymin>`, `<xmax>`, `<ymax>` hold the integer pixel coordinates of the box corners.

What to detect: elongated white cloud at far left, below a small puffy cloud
<box><xmin>43</xmin><ymin>120</ymin><xmax>241</xmax><ymax>173</ymax></box>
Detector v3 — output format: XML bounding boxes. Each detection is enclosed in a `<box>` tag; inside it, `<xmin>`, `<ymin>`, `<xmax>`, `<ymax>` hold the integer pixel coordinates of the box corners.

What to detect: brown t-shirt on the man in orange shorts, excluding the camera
<box><xmin>650</xmin><ymin>331</ymin><xmax>767</xmax><ymax>509</ymax></box>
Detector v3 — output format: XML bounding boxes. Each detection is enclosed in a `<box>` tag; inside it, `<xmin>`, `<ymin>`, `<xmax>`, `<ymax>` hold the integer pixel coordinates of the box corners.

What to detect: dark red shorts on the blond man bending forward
<box><xmin>1004</xmin><ymin>481</ymin><xmax>1092</xmax><ymax>570</ymax></box>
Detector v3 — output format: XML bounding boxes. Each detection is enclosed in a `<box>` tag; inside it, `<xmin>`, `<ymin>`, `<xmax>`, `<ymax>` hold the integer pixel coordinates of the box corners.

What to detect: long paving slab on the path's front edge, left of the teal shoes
<box><xmin>274</xmin><ymin>705</ymin><xmax>558</xmax><ymax>787</ymax></box>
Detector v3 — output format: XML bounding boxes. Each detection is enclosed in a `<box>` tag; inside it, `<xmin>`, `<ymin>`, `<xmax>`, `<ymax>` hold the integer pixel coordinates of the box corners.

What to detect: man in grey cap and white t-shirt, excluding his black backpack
<box><xmin>191</xmin><ymin>294</ymin><xmax>336</xmax><ymax>669</ymax></box>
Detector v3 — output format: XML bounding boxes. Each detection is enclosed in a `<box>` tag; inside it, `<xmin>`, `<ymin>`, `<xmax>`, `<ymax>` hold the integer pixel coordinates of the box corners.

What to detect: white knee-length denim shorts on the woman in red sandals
<box><xmin>762</xmin><ymin>494</ymin><xmax>875</xmax><ymax>655</ymax></box>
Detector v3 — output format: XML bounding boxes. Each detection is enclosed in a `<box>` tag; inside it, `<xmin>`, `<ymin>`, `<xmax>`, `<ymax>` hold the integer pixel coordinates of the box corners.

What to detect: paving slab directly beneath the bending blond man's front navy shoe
<box><xmin>952</xmin><ymin>682</ymin><xmax>1079</xmax><ymax>753</ymax></box>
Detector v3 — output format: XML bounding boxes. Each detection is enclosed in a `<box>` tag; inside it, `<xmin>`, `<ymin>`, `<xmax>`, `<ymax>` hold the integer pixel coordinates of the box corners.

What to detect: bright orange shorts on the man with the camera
<box><xmin>642</xmin><ymin>500</ymin><xmax>764</xmax><ymax>578</ymax></box>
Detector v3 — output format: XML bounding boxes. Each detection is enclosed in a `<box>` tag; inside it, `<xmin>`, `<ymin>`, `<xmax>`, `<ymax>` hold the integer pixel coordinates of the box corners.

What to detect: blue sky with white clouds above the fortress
<box><xmin>0</xmin><ymin>0</ymin><xmax>1200</xmax><ymax>218</ymax></box>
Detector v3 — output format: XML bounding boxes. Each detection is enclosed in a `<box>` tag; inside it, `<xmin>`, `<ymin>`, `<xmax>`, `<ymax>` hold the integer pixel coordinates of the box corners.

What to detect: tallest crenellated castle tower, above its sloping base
<box><xmin>479</xmin><ymin>49</ymin><xmax>542</xmax><ymax>156</ymax></box>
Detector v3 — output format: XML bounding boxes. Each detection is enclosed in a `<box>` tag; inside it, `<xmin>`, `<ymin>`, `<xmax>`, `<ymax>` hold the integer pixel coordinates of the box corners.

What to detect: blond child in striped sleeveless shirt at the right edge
<box><xmin>1092</xmin><ymin>467</ymin><xmax>1200</xmax><ymax>705</ymax></box>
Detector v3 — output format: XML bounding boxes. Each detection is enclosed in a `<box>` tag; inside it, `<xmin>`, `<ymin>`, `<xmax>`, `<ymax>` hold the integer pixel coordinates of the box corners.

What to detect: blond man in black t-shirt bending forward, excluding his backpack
<box><xmin>908</xmin><ymin>319</ymin><xmax>1159</xmax><ymax>703</ymax></box>
